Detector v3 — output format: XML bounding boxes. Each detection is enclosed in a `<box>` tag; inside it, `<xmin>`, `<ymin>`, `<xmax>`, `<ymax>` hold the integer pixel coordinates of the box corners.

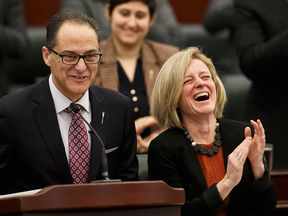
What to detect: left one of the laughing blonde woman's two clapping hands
<box><xmin>217</xmin><ymin>137</ymin><xmax>252</xmax><ymax>200</ymax></box>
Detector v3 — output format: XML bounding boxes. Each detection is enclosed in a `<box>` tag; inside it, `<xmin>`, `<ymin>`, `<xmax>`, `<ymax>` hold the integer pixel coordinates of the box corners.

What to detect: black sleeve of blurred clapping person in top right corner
<box><xmin>235</xmin><ymin>0</ymin><xmax>288</xmax><ymax>82</ymax></box>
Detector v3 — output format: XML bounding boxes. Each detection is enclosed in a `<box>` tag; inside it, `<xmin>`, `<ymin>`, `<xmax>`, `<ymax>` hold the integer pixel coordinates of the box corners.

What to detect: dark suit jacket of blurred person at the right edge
<box><xmin>235</xmin><ymin>0</ymin><xmax>288</xmax><ymax>169</ymax></box>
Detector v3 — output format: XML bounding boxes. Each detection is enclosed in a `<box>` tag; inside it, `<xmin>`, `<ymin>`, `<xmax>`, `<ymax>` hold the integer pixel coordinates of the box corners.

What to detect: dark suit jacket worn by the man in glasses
<box><xmin>0</xmin><ymin>78</ymin><xmax>138</xmax><ymax>194</ymax></box>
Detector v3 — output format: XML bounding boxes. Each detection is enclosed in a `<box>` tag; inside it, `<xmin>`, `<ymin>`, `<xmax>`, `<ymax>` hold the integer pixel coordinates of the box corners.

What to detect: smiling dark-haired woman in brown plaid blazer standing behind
<box><xmin>94</xmin><ymin>0</ymin><xmax>179</xmax><ymax>152</ymax></box>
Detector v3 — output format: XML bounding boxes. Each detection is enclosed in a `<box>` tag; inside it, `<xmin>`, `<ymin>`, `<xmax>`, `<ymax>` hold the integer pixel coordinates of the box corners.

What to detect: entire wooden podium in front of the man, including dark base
<box><xmin>0</xmin><ymin>181</ymin><xmax>185</xmax><ymax>216</ymax></box>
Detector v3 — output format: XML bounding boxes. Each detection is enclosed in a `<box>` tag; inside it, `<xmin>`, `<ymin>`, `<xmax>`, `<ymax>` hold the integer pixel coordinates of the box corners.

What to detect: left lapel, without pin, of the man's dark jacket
<box><xmin>33</xmin><ymin>78</ymin><xmax>73</xmax><ymax>184</ymax></box>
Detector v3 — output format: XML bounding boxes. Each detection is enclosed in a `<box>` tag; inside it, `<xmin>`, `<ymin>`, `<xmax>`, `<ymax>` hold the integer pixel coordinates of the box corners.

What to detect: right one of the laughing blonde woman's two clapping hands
<box><xmin>245</xmin><ymin>119</ymin><xmax>266</xmax><ymax>180</ymax></box>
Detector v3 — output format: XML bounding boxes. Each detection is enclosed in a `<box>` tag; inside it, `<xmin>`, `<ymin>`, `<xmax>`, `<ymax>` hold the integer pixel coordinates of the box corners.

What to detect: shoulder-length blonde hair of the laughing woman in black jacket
<box><xmin>151</xmin><ymin>47</ymin><xmax>227</xmax><ymax>128</ymax></box>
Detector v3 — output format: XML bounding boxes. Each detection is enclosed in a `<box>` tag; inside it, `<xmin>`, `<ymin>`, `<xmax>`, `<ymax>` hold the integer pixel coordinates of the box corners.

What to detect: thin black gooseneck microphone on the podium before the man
<box><xmin>70</xmin><ymin>102</ymin><xmax>121</xmax><ymax>183</ymax></box>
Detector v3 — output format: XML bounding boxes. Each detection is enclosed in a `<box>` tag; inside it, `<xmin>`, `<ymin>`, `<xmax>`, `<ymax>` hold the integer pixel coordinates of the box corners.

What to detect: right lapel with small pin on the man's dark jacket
<box><xmin>88</xmin><ymin>86</ymin><xmax>110</xmax><ymax>182</ymax></box>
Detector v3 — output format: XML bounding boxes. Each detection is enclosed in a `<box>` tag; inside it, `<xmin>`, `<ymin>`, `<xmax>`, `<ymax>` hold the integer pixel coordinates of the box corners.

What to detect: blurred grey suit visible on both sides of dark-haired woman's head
<box><xmin>61</xmin><ymin>0</ymin><xmax>186</xmax><ymax>47</ymax></box>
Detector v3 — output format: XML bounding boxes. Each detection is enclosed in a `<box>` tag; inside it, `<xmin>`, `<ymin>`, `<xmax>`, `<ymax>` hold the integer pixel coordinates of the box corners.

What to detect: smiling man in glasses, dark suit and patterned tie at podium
<box><xmin>0</xmin><ymin>12</ymin><xmax>138</xmax><ymax>194</ymax></box>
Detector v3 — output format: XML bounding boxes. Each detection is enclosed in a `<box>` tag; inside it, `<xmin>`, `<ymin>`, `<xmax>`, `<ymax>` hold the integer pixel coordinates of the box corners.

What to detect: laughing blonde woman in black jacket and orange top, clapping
<box><xmin>148</xmin><ymin>47</ymin><xmax>277</xmax><ymax>216</ymax></box>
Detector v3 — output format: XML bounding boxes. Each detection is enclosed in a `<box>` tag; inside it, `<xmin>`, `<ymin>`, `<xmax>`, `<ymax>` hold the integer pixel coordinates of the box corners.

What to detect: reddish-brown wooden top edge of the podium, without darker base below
<box><xmin>0</xmin><ymin>181</ymin><xmax>185</xmax><ymax>214</ymax></box>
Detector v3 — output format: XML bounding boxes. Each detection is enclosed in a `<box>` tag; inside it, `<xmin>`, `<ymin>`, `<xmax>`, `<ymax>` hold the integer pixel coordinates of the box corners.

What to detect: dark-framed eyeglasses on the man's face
<box><xmin>50</xmin><ymin>48</ymin><xmax>103</xmax><ymax>65</ymax></box>
